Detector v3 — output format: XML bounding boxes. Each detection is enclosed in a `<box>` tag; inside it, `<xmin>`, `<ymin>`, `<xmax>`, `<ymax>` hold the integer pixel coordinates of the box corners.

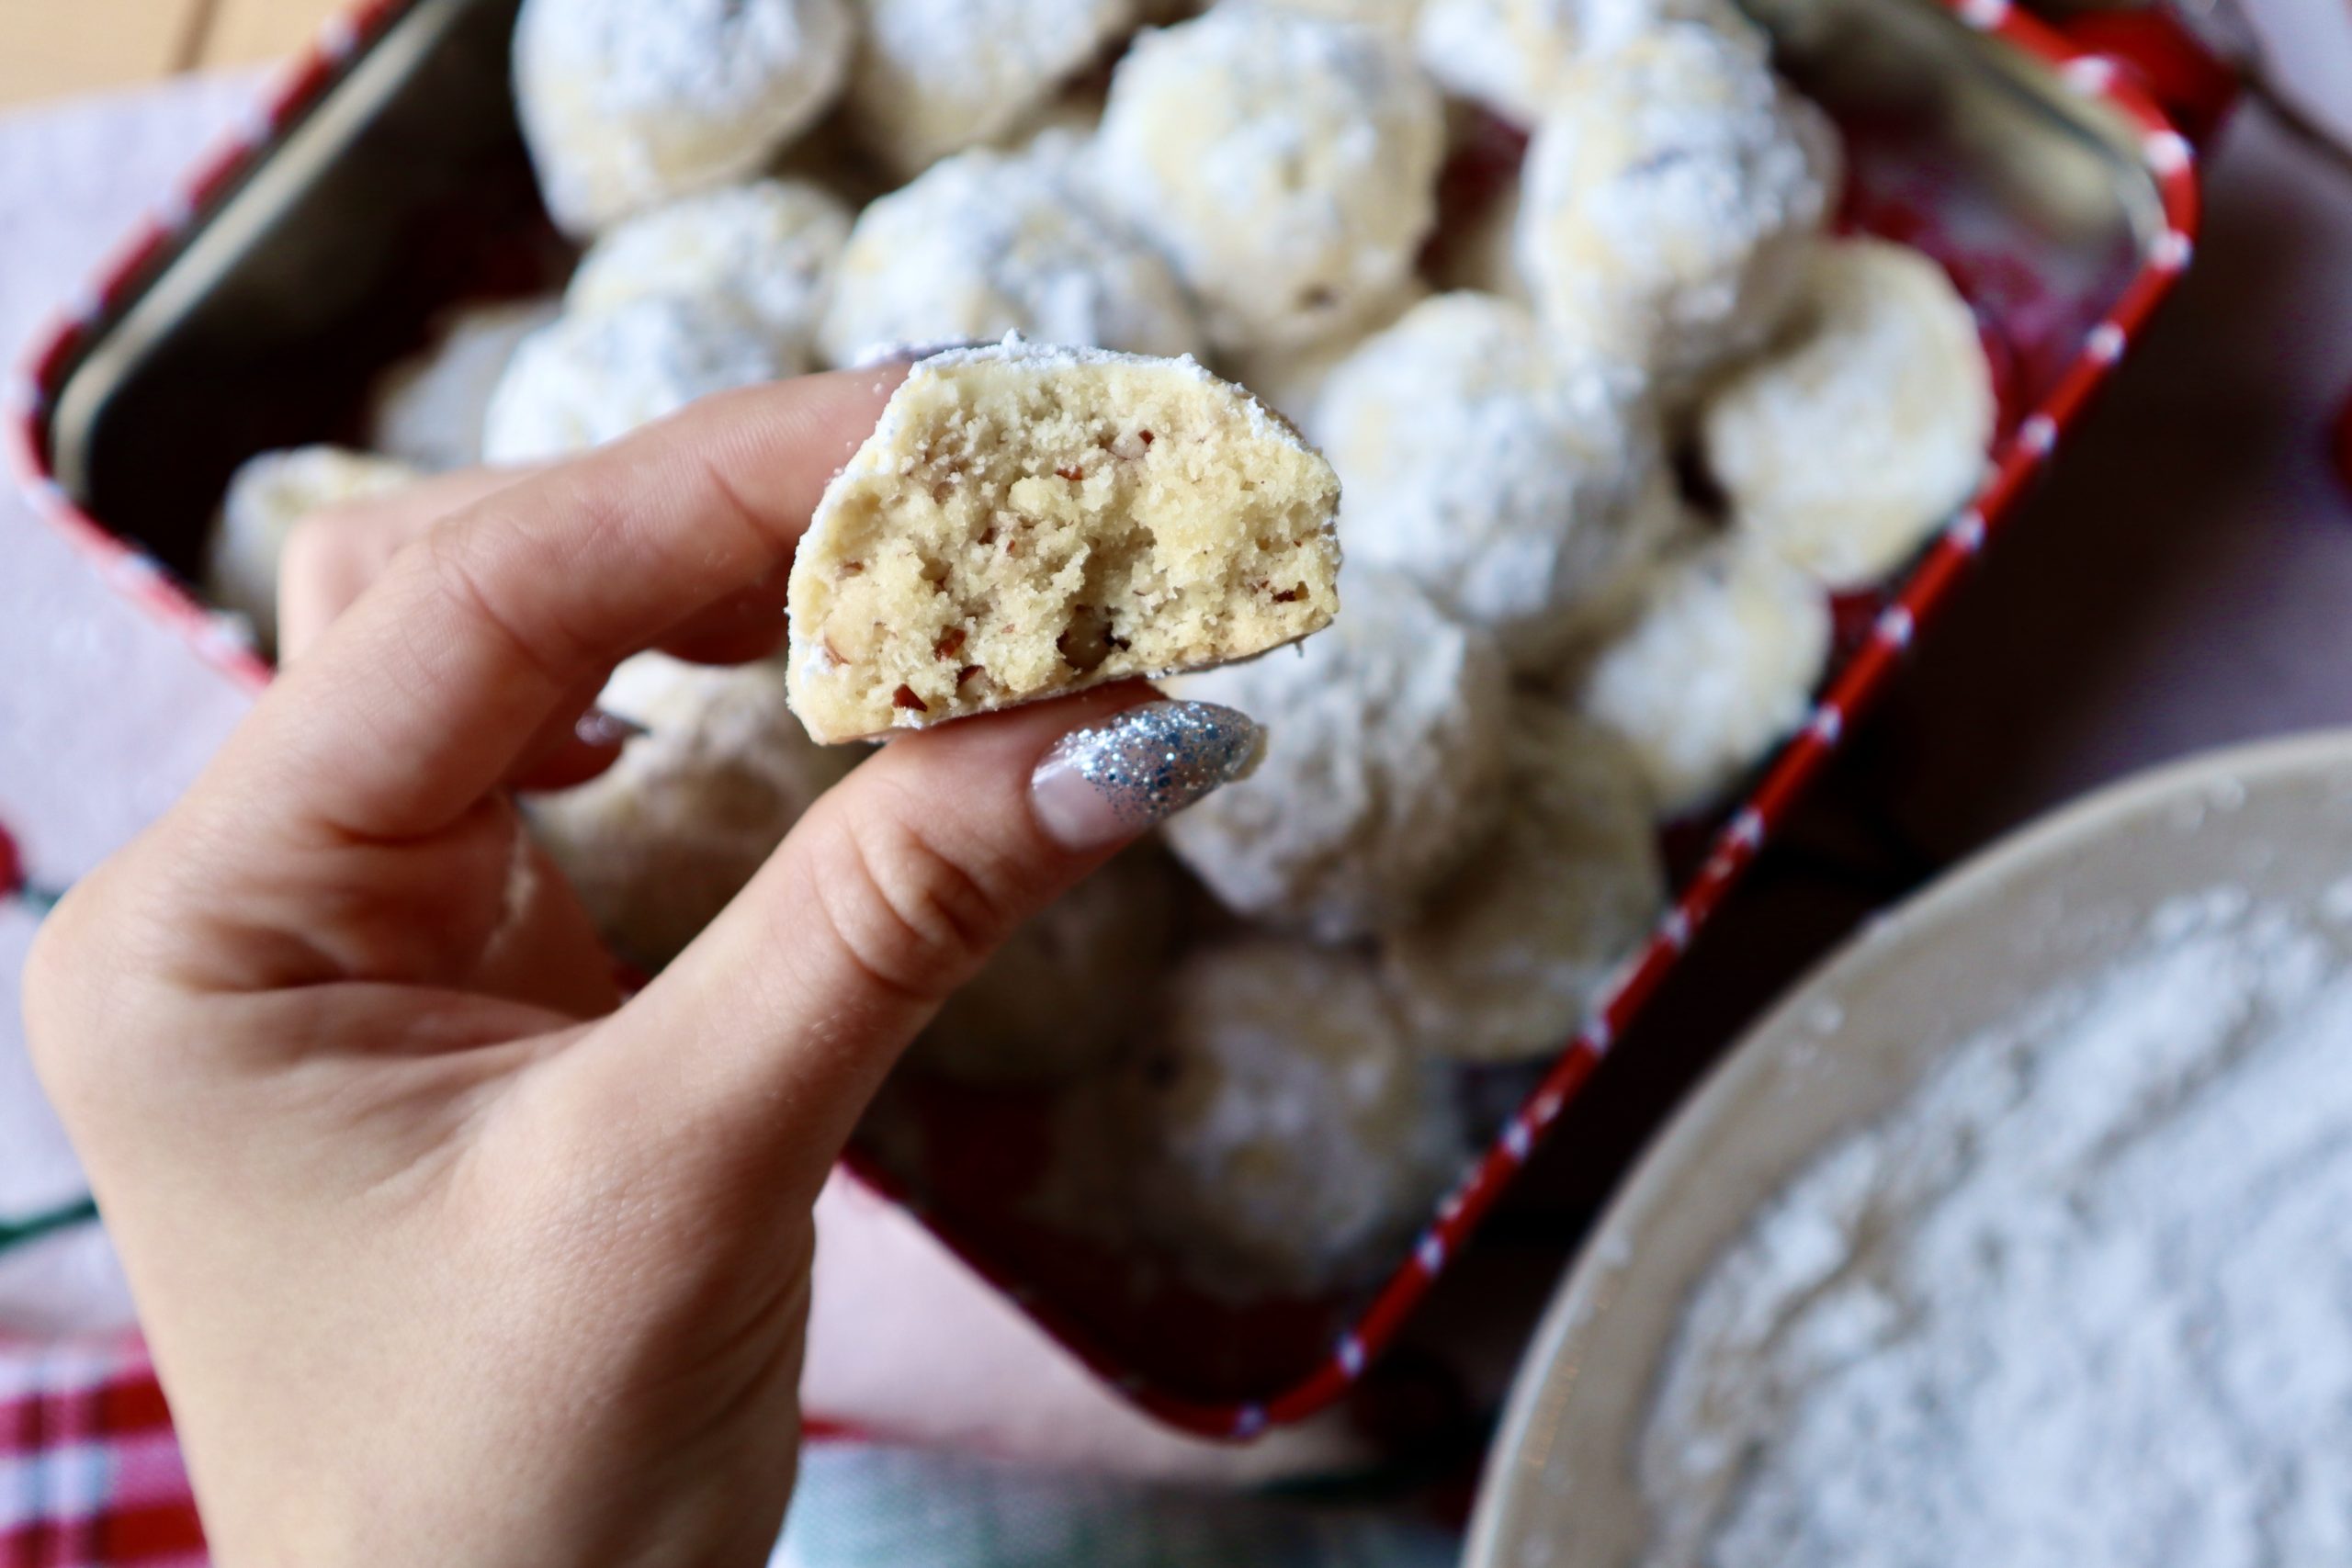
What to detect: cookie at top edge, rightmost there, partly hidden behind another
<box><xmin>1414</xmin><ymin>0</ymin><xmax>1767</xmax><ymax>125</ymax></box>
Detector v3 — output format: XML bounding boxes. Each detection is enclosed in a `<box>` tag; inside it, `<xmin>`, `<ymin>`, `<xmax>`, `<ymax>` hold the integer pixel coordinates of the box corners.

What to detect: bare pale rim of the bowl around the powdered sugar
<box><xmin>1463</xmin><ymin>731</ymin><xmax>2352</xmax><ymax>1568</ymax></box>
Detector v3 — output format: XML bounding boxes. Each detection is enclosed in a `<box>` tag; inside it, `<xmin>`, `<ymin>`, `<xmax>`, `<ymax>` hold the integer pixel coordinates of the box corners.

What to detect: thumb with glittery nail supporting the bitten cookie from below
<box><xmin>567</xmin><ymin>682</ymin><xmax>1261</xmax><ymax>1197</ymax></box>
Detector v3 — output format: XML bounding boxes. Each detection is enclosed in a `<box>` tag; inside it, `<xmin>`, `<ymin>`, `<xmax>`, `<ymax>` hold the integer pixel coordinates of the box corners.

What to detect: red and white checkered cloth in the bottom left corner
<box><xmin>0</xmin><ymin>1336</ymin><xmax>207</xmax><ymax>1568</ymax></box>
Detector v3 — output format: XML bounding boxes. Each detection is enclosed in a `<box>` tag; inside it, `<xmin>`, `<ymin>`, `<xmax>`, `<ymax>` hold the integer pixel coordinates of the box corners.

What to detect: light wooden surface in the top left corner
<box><xmin>0</xmin><ymin>0</ymin><xmax>336</xmax><ymax>108</ymax></box>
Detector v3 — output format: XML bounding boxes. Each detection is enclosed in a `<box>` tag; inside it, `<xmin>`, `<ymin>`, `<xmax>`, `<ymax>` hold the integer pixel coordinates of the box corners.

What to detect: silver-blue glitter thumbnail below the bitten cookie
<box><xmin>1030</xmin><ymin>703</ymin><xmax>1265</xmax><ymax>849</ymax></box>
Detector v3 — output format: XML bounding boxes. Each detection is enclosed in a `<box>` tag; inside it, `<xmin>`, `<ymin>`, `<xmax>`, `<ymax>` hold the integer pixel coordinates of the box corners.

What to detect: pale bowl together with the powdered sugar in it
<box><xmin>1465</xmin><ymin>736</ymin><xmax>2352</xmax><ymax>1568</ymax></box>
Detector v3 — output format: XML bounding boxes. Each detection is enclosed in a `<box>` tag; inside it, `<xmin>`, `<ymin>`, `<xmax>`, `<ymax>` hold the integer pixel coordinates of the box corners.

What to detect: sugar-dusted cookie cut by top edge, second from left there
<box><xmin>849</xmin><ymin>0</ymin><xmax>1136</xmax><ymax>176</ymax></box>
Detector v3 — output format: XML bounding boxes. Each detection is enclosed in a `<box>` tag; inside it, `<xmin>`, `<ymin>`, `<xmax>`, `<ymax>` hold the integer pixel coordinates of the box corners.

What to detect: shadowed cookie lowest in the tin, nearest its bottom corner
<box><xmin>1117</xmin><ymin>936</ymin><xmax>1465</xmax><ymax>1300</ymax></box>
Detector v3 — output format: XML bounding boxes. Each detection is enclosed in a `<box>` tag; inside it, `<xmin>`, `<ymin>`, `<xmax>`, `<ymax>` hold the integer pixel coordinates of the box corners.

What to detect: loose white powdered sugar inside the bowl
<box><xmin>1639</xmin><ymin>886</ymin><xmax>2352</xmax><ymax>1568</ymax></box>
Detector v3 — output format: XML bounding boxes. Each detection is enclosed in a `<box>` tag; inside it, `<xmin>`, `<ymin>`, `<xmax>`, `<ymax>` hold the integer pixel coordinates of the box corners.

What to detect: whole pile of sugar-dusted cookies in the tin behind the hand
<box><xmin>214</xmin><ymin>0</ymin><xmax>1995</xmax><ymax>1298</ymax></box>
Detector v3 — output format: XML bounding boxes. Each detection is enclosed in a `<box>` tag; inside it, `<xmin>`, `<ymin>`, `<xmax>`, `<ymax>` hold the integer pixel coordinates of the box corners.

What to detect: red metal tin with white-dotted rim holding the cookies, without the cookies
<box><xmin>7</xmin><ymin>0</ymin><xmax>2197</xmax><ymax>1437</ymax></box>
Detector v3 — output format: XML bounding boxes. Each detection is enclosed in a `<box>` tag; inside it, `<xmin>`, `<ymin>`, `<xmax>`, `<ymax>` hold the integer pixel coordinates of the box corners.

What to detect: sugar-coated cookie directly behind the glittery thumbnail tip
<box><xmin>1167</xmin><ymin>569</ymin><xmax>1510</xmax><ymax>941</ymax></box>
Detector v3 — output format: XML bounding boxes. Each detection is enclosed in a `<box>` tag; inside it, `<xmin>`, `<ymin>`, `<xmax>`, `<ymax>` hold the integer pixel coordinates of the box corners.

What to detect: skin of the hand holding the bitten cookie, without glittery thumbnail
<box><xmin>26</xmin><ymin>371</ymin><xmax>1250</xmax><ymax>1568</ymax></box>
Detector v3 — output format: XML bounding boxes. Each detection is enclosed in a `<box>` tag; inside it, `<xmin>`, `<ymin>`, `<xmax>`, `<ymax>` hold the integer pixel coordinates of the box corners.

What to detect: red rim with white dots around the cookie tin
<box><xmin>5</xmin><ymin>0</ymin><xmax>2199</xmax><ymax>1438</ymax></box>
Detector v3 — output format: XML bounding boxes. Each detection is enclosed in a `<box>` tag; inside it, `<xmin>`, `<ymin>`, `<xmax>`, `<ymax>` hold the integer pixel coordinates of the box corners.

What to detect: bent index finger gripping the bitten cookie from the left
<box><xmin>221</xmin><ymin>367</ymin><xmax>903</xmax><ymax>840</ymax></box>
